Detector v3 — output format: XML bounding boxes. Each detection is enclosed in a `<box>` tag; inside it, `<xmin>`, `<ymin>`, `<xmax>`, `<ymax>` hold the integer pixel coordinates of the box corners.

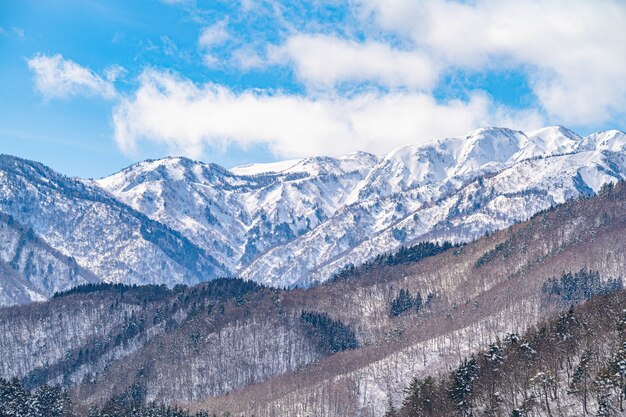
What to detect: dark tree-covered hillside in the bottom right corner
<box><xmin>385</xmin><ymin>290</ymin><xmax>626</xmax><ymax>417</ymax></box>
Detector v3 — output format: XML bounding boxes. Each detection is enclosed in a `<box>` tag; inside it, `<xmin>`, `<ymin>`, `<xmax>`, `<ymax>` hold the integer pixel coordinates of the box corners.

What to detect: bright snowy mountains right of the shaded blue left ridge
<box><xmin>97</xmin><ymin>127</ymin><xmax>626</xmax><ymax>286</ymax></box>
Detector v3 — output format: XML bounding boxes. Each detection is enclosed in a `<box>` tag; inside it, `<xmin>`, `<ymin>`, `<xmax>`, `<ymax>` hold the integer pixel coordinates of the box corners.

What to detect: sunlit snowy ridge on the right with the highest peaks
<box><xmin>240</xmin><ymin>127</ymin><xmax>626</xmax><ymax>285</ymax></box>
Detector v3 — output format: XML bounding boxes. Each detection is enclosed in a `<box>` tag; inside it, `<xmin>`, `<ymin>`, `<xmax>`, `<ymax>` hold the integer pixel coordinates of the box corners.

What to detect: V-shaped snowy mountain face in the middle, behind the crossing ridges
<box><xmin>98</xmin><ymin>153</ymin><xmax>378</xmax><ymax>273</ymax></box>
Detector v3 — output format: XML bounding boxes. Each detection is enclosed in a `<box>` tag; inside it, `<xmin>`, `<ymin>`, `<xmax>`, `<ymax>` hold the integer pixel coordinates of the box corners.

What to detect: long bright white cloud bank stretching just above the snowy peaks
<box><xmin>113</xmin><ymin>70</ymin><xmax>542</xmax><ymax>157</ymax></box>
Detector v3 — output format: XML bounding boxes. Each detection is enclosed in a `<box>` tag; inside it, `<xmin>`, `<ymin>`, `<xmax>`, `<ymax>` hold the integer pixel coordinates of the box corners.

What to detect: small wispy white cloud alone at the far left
<box><xmin>27</xmin><ymin>54</ymin><xmax>117</xmax><ymax>99</ymax></box>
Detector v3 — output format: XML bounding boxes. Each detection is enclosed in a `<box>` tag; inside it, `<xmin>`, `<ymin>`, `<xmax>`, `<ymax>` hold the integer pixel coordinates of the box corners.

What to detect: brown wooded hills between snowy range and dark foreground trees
<box><xmin>0</xmin><ymin>183</ymin><xmax>626</xmax><ymax>416</ymax></box>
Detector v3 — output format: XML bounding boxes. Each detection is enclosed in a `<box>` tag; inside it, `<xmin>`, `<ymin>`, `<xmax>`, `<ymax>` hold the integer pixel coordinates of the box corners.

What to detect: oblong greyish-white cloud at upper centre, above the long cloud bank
<box><xmin>271</xmin><ymin>34</ymin><xmax>439</xmax><ymax>89</ymax></box>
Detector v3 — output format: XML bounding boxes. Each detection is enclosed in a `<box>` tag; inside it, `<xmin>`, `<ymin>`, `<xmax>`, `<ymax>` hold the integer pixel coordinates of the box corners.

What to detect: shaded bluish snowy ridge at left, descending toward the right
<box><xmin>0</xmin><ymin>155</ymin><xmax>228</xmax><ymax>300</ymax></box>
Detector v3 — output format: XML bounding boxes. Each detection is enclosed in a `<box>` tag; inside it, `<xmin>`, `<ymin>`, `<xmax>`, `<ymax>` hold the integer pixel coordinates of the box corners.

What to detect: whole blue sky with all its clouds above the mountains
<box><xmin>0</xmin><ymin>0</ymin><xmax>626</xmax><ymax>177</ymax></box>
